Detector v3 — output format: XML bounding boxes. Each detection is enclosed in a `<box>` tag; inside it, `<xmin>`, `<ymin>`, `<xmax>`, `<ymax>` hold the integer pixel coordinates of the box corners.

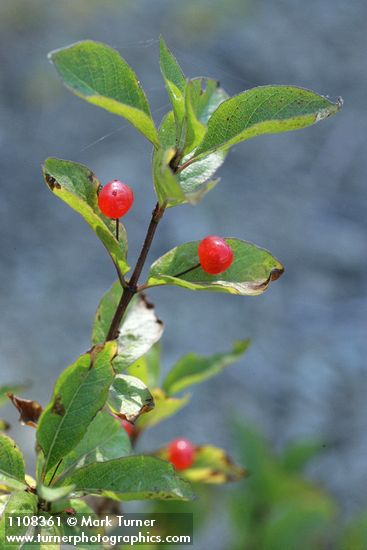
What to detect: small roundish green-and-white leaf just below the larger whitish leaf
<box><xmin>107</xmin><ymin>374</ymin><xmax>154</xmax><ymax>422</ymax></box>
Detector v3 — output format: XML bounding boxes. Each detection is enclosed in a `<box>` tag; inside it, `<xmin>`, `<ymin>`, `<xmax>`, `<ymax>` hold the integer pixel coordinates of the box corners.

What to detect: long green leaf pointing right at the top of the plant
<box><xmin>191</xmin><ymin>86</ymin><xmax>342</xmax><ymax>159</ymax></box>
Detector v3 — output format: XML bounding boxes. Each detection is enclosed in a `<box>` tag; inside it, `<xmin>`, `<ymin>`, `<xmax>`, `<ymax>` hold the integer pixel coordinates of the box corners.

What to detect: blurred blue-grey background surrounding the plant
<box><xmin>0</xmin><ymin>0</ymin><xmax>367</xmax><ymax>548</ymax></box>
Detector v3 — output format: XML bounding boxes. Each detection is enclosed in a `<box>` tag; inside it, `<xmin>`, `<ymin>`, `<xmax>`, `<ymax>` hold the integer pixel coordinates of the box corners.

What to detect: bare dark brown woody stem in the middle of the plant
<box><xmin>106</xmin><ymin>203</ymin><xmax>166</xmax><ymax>342</ymax></box>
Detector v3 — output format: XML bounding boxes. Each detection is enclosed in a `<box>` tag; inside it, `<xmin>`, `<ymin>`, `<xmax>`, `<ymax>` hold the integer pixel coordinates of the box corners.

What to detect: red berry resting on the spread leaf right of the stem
<box><xmin>198</xmin><ymin>235</ymin><xmax>233</xmax><ymax>275</ymax></box>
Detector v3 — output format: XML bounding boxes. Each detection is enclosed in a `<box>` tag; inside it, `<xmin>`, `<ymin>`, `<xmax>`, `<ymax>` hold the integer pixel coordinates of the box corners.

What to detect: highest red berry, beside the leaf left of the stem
<box><xmin>98</xmin><ymin>180</ymin><xmax>134</xmax><ymax>219</ymax></box>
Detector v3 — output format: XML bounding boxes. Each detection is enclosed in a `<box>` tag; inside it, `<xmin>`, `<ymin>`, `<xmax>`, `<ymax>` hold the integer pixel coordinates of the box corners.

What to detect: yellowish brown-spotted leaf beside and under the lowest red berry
<box><xmin>157</xmin><ymin>445</ymin><xmax>247</xmax><ymax>485</ymax></box>
